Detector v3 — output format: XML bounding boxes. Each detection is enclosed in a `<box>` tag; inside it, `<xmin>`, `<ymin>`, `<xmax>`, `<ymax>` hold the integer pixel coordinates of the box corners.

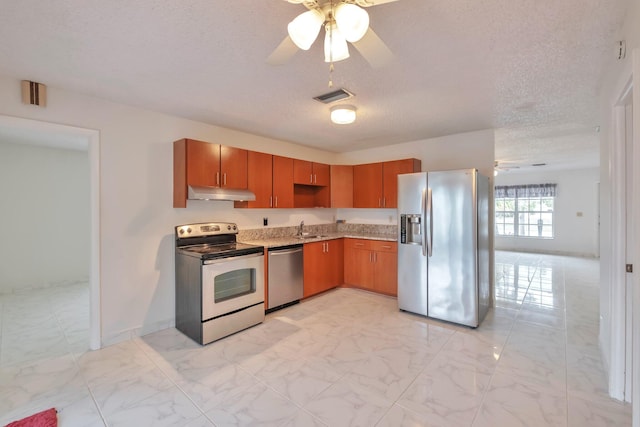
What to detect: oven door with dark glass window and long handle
<box><xmin>202</xmin><ymin>253</ymin><xmax>264</xmax><ymax>321</ymax></box>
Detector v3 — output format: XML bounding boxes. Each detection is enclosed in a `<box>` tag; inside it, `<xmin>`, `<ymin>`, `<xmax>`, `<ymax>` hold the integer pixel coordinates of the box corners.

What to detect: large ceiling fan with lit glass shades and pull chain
<box><xmin>267</xmin><ymin>0</ymin><xmax>397</xmax><ymax>68</ymax></box>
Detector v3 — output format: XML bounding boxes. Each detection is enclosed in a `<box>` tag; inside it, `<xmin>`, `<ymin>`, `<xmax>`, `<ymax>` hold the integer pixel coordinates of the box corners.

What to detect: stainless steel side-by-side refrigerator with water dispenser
<box><xmin>398</xmin><ymin>169</ymin><xmax>490</xmax><ymax>328</ymax></box>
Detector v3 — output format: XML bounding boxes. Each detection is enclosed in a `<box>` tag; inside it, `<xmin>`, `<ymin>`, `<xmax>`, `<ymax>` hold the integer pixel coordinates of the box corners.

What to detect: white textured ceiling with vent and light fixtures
<box><xmin>0</xmin><ymin>0</ymin><xmax>628</xmax><ymax>171</ymax></box>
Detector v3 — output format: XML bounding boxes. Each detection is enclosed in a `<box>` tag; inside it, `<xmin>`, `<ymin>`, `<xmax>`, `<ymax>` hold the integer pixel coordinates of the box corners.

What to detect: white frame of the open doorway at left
<box><xmin>0</xmin><ymin>115</ymin><xmax>102</xmax><ymax>350</ymax></box>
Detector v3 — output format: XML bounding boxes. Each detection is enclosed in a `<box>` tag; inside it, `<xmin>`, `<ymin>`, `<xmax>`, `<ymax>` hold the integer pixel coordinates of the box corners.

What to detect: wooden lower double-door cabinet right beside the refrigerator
<box><xmin>344</xmin><ymin>239</ymin><xmax>398</xmax><ymax>296</ymax></box>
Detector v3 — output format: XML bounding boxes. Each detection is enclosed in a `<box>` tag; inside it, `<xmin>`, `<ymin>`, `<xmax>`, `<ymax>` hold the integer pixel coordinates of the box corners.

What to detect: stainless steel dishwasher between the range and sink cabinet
<box><xmin>267</xmin><ymin>245</ymin><xmax>303</xmax><ymax>311</ymax></box>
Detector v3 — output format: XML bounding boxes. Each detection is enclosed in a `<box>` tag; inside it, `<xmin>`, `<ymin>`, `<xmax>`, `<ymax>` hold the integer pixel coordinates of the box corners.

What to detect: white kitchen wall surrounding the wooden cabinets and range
<box><xmin>0</xmin><ymin>76</ymin><xmax>493</xmax><ymax>345</ymax></box>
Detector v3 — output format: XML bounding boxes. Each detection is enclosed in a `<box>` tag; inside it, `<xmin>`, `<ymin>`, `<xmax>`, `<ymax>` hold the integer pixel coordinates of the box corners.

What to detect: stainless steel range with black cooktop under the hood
<box><xmin>175</xmin><ymin>222</ymin><xmax>264</xmax><ymax>344</ymax></box>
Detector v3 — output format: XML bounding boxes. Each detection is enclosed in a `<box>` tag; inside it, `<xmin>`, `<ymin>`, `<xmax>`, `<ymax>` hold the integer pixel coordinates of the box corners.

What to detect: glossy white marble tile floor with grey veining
<box><xmin>0</xmin><ymin>252</ymin><xmax>631</xmax><ymax>427</ymax></box>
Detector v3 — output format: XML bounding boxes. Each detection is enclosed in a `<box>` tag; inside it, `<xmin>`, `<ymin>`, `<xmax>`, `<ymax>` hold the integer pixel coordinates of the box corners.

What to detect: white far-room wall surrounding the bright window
<box><xmin>495</xmin><ymin>168</ymin><xmax>600</xmax><ymax>257</ymax></box>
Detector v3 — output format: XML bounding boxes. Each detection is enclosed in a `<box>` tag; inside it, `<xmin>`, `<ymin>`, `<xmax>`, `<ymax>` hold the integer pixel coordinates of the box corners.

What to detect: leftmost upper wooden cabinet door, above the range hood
<box><xmin>186</xmin><ymin>139</ymin><xmax>220</xmax><ymax>187</ymax></box>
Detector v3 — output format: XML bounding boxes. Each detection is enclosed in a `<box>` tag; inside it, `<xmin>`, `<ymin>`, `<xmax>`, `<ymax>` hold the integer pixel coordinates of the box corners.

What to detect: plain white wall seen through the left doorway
<box><xmin>0</xmin><ymin>141</ymin><xmax>90</xmax><ymax>293</ymax></box>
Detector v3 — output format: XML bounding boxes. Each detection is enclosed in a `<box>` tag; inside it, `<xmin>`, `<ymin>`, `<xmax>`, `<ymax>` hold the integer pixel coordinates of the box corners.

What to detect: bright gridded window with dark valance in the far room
<box><xmin>495</xmin><ymin>184</ymin><xmax>556</xmax><ymax>239</ymax></box>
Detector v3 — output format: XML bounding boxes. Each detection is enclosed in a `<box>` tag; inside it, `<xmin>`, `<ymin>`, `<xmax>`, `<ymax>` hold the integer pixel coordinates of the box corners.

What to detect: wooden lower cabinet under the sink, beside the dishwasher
<box><xmin>303</xmin><ymin>239</ymin><xmax>344</xmax><ymax>298</ymax></box>
